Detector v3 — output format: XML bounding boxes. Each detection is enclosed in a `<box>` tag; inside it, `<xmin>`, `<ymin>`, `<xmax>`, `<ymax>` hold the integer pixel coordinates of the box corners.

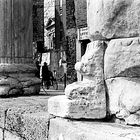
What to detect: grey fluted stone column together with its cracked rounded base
<box><xmin>0</xmin><ymin>0</ymin><xmax>40</xmax><ymax>96</ymax></box>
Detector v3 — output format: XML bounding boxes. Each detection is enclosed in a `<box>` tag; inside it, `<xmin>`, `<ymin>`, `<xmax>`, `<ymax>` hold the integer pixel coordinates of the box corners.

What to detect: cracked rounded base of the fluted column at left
<box><xmin>0</xmin><ymin>64</ymin><xmax>41</xmax><ymax>97</ymax></box>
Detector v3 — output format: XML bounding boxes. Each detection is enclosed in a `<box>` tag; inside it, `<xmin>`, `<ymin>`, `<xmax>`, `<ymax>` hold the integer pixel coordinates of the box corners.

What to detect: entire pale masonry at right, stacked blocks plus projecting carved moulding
<box><xmin>48</xmin><ymin>0</ymin><xmax>140</xmax><ymax>125</ymax></box>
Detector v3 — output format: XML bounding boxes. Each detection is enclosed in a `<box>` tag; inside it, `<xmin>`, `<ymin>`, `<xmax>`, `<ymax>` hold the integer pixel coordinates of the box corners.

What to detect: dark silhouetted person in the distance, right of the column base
<box><xmin>42</xmin><ymin>62</ymin><xmax>54</xmax><ymax>89</ymax></box>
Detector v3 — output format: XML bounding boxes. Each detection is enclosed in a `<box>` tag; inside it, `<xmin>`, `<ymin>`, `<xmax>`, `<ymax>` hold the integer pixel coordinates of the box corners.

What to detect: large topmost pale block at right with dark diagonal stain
<box><xmin>87</xmin><ymin>0</ymin><xmax>140</xmax><ymax>40</ymax></box>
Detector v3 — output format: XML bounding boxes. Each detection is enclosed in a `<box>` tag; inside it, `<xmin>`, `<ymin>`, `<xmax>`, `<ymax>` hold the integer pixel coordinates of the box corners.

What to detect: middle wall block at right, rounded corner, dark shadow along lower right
<box><xmin>104</xmin><ymin>37</ymin><xmax>140</xmax><ymax>79</ymax></box>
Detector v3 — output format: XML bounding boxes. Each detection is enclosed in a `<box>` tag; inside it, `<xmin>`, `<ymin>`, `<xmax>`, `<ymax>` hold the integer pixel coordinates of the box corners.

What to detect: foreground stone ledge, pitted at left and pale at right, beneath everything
<box><xmin>0</xmin><ymin>95</ymin><xmax>140</xmax><ymax>140</ymax></box>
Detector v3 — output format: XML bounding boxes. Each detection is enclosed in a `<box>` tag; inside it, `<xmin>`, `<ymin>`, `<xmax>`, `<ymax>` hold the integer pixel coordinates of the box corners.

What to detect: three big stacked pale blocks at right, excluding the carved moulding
<box><xmin>88</xmin><ymin>0</ymin><xmax>140</xmax><ymax>125</ymax></box>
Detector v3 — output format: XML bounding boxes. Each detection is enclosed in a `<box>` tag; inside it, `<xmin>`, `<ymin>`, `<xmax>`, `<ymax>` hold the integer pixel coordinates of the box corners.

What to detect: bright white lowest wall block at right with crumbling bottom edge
<box><xmin>106</xmin><ymin>77</ymin><xmax>140</xmax><ymax>125</ymax></box>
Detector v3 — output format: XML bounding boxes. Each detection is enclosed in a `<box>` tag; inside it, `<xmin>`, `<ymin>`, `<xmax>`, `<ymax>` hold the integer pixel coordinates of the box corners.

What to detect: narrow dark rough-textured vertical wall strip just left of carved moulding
<box><xmin>66</xmin><ymin>0</ymin><xmax>77</xmax><ymax>83</ymax></box>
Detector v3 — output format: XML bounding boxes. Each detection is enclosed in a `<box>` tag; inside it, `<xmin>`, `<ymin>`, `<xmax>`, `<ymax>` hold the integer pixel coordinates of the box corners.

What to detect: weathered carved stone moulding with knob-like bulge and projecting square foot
<box><xmin>48</xmin><ymin>41</ymin><xmax>106</xmax><ymax>119</ymax></box>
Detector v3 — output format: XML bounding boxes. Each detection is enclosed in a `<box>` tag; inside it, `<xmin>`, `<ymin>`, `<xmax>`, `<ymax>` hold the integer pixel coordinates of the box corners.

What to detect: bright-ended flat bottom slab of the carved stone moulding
<box><xmin>48</xmin><ymin>95</ymin><xmax>106</xmax><ymax>119</ymax></box>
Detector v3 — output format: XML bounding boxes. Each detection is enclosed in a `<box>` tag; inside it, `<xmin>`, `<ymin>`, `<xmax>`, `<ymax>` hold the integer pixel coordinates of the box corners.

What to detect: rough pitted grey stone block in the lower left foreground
<box><xmin>0</xmin><ymin>95</ymin><xmax>53</xmax><ymax>140</ymax></box>
